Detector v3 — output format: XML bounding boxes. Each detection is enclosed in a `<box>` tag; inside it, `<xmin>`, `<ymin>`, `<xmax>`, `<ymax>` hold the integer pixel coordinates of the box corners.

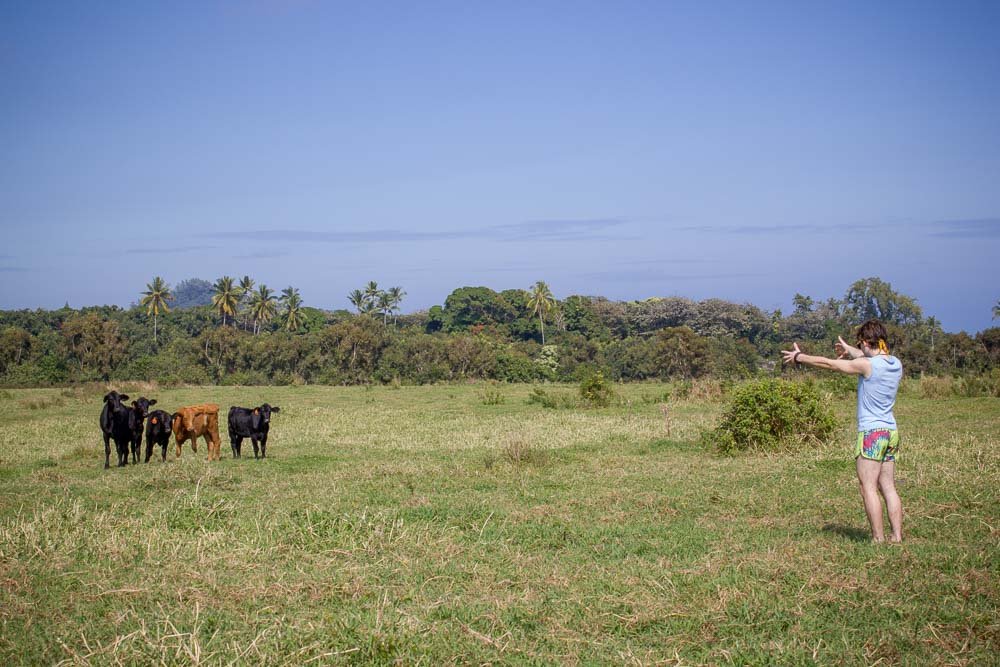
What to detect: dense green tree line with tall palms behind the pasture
<box><xmin>0</xmin><ymin>276</ymin><xmax>1000</xmax><ymax>386</ymax></box>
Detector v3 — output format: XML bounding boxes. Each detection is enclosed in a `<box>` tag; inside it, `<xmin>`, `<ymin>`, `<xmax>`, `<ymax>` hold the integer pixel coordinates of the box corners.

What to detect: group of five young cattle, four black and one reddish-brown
<box><xmin>101</xmin><ymin>391</ymin><xmax>281</xmax><ymax>468</ymax></box>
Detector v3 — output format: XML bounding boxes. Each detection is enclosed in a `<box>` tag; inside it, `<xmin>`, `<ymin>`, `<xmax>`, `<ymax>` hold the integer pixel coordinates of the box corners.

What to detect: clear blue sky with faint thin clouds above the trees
<box><xmin>0</xmin><ymin>0</ymin><xmax>1000</xmax><ymax>331</ymax></box>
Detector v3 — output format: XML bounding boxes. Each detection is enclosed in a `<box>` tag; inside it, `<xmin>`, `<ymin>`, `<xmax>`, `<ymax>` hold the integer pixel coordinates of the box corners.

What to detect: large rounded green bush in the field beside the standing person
<box><xmin>702</xmin><ymin>380</ymin><xmax>836</xmax><ymax>454</ymax></box>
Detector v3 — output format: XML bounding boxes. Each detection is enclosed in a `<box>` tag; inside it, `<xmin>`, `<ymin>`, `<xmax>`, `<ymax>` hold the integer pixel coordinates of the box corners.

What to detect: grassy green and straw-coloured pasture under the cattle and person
<box><xmin>0</xmin><ymin>385</ymin><xmax>1000</xmax><ymax>665</ymax></box>
